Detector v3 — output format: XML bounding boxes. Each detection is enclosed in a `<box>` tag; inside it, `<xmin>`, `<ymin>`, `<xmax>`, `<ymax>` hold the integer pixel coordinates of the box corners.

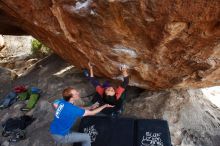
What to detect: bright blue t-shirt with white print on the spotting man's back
<box><xmin>50</xmin><ymin>100</ymin><xmax>85</xmax><ymax>136</ymax></box>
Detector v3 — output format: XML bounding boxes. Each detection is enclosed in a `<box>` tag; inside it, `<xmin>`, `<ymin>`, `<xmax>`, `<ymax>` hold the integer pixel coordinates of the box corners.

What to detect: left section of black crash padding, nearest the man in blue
<box><xmin>79</xmin><ymin>116</ymin><xmax>134</xmax><ymax>146</ymax></box>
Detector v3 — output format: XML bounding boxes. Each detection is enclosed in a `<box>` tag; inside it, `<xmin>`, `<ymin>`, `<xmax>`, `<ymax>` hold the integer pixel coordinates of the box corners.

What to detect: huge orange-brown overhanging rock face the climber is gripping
<box><xmin>0</xmin><ymin>0</ymin><xmax>220</xmax><ymax>90</ymax></box>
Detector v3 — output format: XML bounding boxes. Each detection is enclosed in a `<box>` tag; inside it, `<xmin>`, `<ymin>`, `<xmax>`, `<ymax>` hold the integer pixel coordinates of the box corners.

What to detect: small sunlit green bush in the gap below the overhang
<box><xmin>31</xmin><ymin>39</ymin><xmax>52</xmax><ymax>57</ymax></box>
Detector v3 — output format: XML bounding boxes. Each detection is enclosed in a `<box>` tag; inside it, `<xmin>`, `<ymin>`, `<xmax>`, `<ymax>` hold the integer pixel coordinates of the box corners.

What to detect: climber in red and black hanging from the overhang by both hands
<box><xmin>83</xmin><ymin>63</ymin><xmax>129</xmax><ymax>116</ymax></box>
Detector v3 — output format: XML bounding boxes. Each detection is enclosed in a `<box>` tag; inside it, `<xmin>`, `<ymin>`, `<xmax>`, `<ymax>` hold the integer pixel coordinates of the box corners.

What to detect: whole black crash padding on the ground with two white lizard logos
<box><xmin>75</xmin><ymin>116</ymin><xmax>171</xmax><ymax>146</ymax></box>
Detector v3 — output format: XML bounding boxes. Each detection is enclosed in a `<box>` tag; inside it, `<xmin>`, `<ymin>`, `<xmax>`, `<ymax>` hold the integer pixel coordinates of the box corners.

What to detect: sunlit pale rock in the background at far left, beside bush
<box><xmin>0</xmin><ymin>35</ymin><xmax>38</xmax><ymax>76</ymax></box>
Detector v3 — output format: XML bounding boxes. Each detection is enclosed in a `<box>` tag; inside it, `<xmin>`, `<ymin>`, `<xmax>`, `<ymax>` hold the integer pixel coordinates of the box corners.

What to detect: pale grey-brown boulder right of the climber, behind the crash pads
<box><xmin>125</xmin><ymin>90</ymin><xmax>220</xmax><ymax>146</ymax></box>
